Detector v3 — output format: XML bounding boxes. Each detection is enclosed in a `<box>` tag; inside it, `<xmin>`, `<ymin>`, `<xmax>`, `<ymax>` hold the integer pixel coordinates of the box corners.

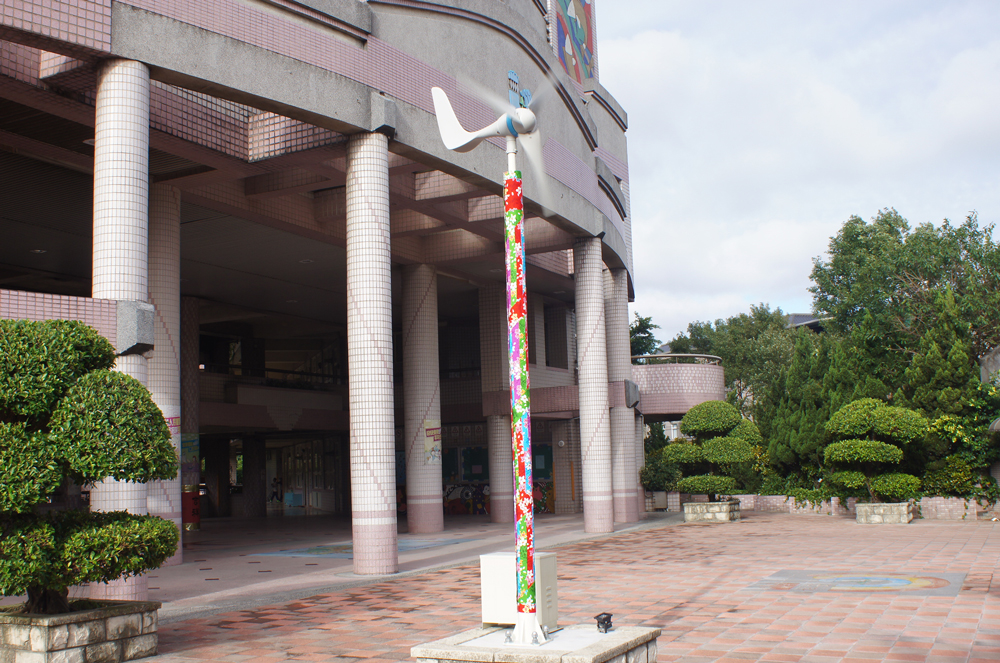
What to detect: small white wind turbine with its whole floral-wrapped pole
<box><xmin>431</xmin><ymin>80</ymin><xmax>548</xmax><ymax>645</ymax></box>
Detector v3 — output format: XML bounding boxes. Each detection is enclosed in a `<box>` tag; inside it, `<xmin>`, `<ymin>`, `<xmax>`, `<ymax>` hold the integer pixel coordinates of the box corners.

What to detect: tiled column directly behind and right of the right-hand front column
<box><xmin>604</xmin><ymin>269</ymin><xmax>639</xmax><ymax>523</ymax></box>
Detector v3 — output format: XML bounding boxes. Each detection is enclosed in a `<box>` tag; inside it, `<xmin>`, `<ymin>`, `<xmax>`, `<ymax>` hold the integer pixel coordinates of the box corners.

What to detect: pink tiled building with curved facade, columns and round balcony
<box><xmin>0</xmin><ymin>0</ymin><xmax>723</xmax><ymax>597</ymax></box>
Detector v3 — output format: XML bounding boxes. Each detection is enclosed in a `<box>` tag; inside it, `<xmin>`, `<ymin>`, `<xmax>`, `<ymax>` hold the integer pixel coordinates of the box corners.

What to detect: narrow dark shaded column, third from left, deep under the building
<box><xmin>181</xmin><ymin>297</ymin><xmax>201</xmax><ymax>530</ymax></box>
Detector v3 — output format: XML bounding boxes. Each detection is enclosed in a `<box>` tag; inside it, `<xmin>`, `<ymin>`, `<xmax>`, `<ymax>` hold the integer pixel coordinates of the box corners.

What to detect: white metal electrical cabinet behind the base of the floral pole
<box><xmin>479</xmin><ymin>552</ymin><xmax>559</xmax><ymax>630</ymax></box>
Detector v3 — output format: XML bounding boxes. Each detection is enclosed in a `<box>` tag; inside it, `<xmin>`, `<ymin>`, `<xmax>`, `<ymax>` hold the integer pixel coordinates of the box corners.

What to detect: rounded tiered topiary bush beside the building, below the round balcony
<box><xmin>661</xmin><ymin>401</ymin><xmax>763</xmax><ymax>502</ymax></box>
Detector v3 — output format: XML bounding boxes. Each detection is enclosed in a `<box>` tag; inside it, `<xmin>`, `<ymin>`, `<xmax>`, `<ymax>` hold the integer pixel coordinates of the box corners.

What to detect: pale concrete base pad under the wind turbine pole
<box><xmin>410</xmin><ymin>624</ymin><xmax>660</xmax><ymax>663</ymax></box>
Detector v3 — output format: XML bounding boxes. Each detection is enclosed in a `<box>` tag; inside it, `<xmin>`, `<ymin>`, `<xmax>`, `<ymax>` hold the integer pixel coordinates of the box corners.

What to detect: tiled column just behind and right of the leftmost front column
<box><xmin>146</xmin><ymin>184</ymin><xmax>183</xmax><ymax>565</ymax></box>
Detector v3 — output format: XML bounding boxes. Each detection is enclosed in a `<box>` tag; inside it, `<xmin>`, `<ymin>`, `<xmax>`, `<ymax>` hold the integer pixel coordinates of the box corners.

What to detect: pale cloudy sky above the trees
<box><xmin>596</xmin><ymin>0</ymin><xmax>1000</xmax><ymax>340</ymax></box>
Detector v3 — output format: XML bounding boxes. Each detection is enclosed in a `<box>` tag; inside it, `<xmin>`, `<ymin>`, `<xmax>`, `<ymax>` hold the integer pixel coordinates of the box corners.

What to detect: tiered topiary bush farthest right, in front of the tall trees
<box><xmin>824</xmin><ymin>398</ymin><xmax>927</xmax><ymax>502</ymax></box>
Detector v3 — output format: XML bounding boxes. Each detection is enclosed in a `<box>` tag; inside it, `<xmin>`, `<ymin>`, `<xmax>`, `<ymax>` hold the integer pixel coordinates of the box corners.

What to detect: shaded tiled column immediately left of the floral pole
<box><xmin>479</xmin><ymin>284</ymin><xmax>514</xmax><ymax>523</ymax></box>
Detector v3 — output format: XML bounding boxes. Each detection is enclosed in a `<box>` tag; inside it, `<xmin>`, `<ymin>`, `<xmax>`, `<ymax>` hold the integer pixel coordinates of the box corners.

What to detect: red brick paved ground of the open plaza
<box><xmin>155</xmin><ymin>514</ymin><xmax>1000</xmax><ymax>663</ymax></box>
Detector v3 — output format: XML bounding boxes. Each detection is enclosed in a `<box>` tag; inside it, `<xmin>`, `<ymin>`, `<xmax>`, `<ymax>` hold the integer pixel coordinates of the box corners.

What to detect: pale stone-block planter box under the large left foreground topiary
<box><xmin>0</xmin><ymin>601</ymin><xmax>161</xmax><ymax>663</ymax></box>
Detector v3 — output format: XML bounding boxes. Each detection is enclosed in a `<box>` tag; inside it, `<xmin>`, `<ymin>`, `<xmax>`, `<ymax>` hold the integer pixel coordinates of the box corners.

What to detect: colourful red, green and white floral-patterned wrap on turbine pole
<box><xmin>504</xmin><ymin>170</ymin><xmax>542</xmax><ymax>624</ymax></box>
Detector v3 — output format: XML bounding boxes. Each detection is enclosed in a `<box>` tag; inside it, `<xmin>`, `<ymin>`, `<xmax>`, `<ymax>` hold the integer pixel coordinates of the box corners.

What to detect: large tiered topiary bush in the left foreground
<box><xmin>0</xmin><ymin>320</ymin><xmax>178</xmax><ymax>614</ymax></box>
